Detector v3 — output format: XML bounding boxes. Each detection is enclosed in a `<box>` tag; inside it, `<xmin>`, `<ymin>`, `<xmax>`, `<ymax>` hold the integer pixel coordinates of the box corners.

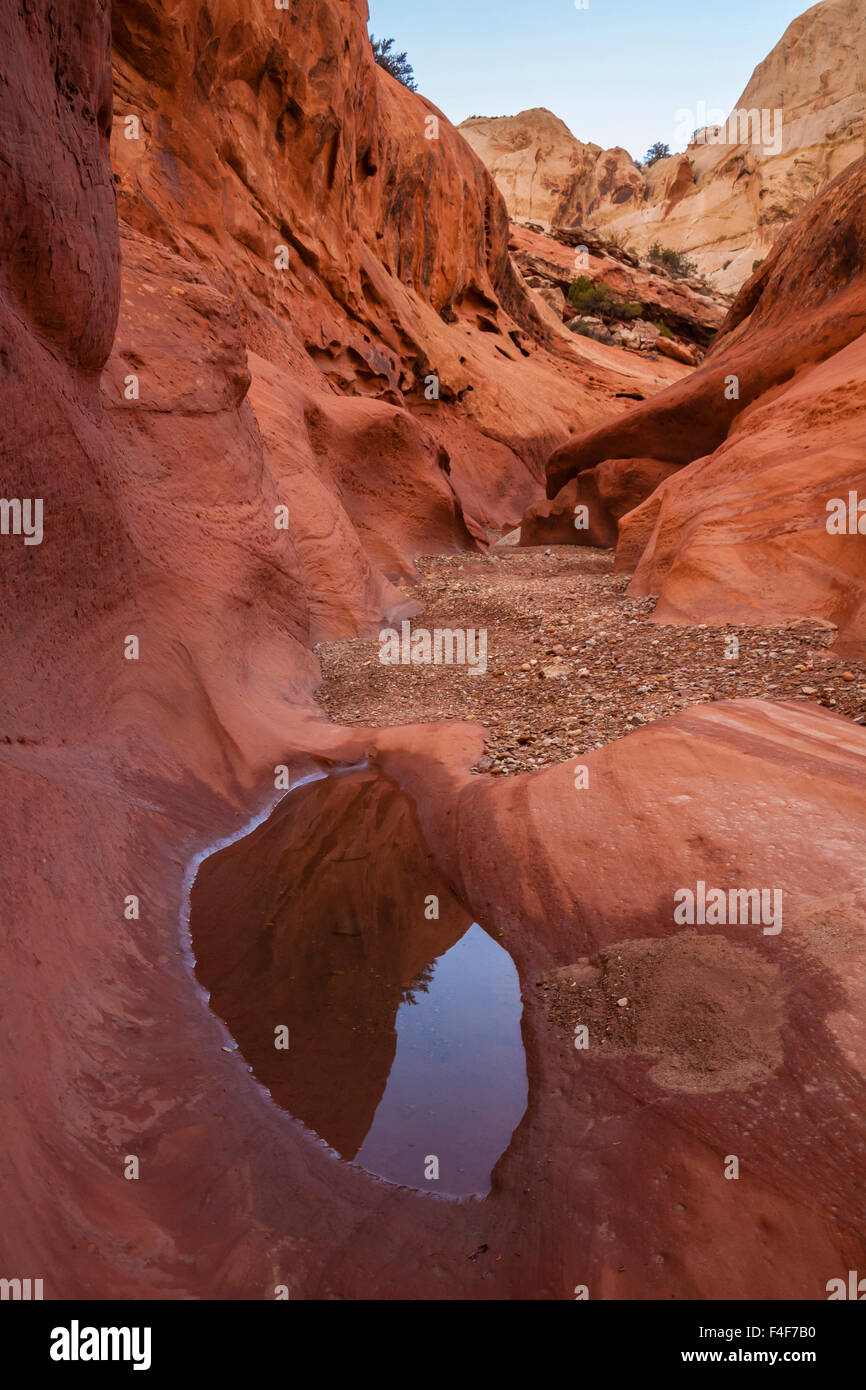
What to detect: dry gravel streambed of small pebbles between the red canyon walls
<box><xmin>316</xmin><ymin>546</ymin><xmax>866</xmax><ymax>774</ymax></box>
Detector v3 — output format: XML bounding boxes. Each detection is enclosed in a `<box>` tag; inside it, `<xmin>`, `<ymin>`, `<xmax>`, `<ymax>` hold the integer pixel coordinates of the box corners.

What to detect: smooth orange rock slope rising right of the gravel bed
<box><xmin>527</xmin><ymin>158</ymin><xmax>866</xmax><ymax>652</ymax></box>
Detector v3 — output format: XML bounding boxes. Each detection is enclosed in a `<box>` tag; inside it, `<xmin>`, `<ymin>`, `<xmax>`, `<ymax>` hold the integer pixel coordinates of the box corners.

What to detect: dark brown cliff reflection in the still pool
<box><xmin>190</xmin><ymin>771</ymin><xmax>471</xmax><ymax>1158</ymax></box>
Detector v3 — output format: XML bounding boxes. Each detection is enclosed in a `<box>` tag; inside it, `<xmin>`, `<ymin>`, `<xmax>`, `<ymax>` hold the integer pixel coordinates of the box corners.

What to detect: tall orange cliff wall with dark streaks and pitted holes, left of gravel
<box><xmin>111</xmin><ymin>0</ymin><xmax>681</xmax><ymax>581</ymax></box>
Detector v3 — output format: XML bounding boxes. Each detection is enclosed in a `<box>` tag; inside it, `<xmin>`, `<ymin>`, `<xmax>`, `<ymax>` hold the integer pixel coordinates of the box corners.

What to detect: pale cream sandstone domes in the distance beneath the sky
<box><xmin>460</xmin><ymin>0</ymin><xmax>866</xmax><ymax>291</ymax></box>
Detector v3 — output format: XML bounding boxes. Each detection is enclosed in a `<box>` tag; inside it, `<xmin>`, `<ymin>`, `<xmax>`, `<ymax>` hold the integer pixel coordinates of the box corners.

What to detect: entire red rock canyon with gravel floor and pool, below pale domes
<box><xmin>0</xmin><ymin>0</ymin><xmax>866</xmax><ymax>1321</ymax></box>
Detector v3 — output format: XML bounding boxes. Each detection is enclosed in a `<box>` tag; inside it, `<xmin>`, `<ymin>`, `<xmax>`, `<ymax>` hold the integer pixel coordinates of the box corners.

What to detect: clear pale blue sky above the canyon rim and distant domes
<box><xmin>368</xmin><ymin>0</ymin><xmax>810</xmax><ymax>158</ymax></box>
